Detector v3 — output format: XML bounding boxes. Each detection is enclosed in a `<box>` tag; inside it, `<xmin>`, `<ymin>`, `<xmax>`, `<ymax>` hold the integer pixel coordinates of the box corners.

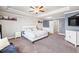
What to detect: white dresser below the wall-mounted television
<box><xmin>65</xmin><ymin>30</ymin><xmax>79</xmax><ymax>47</ymax></box>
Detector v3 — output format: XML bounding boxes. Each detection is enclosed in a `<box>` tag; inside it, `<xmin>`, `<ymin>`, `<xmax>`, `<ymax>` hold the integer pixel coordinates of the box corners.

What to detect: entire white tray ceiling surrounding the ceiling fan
<box><xmin>0</xmin><ymin>6</ymin><xmax>79</xmax><ymax>17</ymax></box>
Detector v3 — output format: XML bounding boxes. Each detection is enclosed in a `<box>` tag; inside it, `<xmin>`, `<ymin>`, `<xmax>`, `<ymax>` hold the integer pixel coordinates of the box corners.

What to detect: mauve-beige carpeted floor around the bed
<box><xmin>9</xmin><ymin>34</ymin><xmax>79</xmax><ymax>53</ymax></box>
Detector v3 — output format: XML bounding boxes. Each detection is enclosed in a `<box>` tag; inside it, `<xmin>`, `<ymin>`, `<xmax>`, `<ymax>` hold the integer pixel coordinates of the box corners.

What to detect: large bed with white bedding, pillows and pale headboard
<box><xmin>22</xmin><ymin>26</ymin><xmax>48</xmax><ymax>42</ymax></box>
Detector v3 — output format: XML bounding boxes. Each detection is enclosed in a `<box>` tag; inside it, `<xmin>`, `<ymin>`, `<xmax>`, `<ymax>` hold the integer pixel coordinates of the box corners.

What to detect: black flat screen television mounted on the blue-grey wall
<box><xmin>68</xmin><ymin>16</ymin><xmax>79</xmax><ymax>26</ymax></box>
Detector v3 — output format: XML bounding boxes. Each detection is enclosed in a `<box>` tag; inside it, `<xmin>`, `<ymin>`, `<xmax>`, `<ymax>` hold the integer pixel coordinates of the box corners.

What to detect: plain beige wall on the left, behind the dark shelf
<box><xmin>0</xmin><ymin>12</ymin><xmax>38</xmax><ymax>37</ymax></box>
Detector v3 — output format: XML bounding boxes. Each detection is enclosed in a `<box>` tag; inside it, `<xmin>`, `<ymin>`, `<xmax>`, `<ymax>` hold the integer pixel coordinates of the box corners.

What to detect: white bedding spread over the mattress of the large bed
<box><xmin>22</xmin><ymin>27</ymin><xmax>48</xmax><ymax>42</ymax></box>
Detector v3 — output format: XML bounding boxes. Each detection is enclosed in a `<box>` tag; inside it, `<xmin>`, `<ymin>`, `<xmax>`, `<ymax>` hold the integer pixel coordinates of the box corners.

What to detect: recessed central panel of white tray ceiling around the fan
<box><xmin>9</xmin><ymin>6</ymin><xmax>64</xmax><ymax>15</ymax></box>
